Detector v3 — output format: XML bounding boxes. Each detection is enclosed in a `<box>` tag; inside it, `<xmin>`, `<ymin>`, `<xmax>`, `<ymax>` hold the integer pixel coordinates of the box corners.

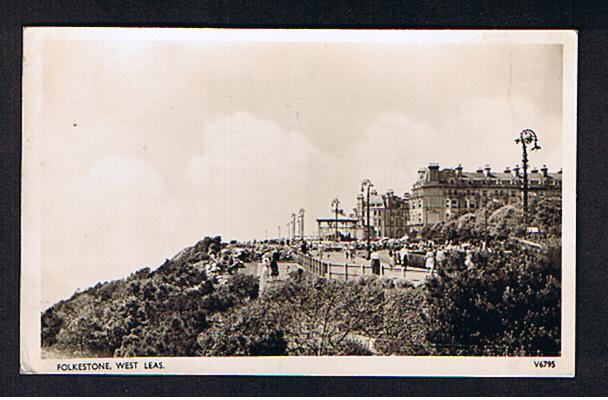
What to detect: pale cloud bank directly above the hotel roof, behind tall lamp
<box><xmin>350</xmin><ymin>96</ymin><xmax>562</xmax><ymax>192</ymax></box>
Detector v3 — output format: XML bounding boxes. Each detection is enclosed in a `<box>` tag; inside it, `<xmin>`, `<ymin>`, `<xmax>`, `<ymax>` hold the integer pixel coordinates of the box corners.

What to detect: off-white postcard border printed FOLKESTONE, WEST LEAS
<box><xmin>20</xmin><ymin>27</ymin><xmax>577</xmax><ymax>377</ymax></box>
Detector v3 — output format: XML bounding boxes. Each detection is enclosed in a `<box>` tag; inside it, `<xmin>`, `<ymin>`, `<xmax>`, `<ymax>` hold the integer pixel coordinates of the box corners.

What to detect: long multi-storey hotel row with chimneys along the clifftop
<box><xmin>346</xmin><ymin>164</ymin><xmax>562</xmax><ymax>239</ymax></box>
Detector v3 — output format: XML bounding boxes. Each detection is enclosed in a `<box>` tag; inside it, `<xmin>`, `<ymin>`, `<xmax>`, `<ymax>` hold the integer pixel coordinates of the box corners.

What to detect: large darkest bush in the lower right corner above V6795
<box><xmin>425</xmin><ymin>244</ymin><xmax>561</xmax><ymax>356</ymax></box>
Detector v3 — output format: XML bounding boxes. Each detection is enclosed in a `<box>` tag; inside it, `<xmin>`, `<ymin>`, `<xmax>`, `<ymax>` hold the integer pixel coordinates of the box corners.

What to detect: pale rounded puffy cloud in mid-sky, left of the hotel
<box><xmin>188</xmin><ymin>112</ymin><xmax>321</xmax><ymax>239</ymax></box>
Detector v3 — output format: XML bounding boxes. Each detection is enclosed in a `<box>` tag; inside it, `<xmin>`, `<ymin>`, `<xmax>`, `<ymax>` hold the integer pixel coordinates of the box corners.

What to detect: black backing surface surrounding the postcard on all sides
<box><xmin>0</xmin><ymin>0</ymin><xmax>608</xmax><ymax>396</ymax></box>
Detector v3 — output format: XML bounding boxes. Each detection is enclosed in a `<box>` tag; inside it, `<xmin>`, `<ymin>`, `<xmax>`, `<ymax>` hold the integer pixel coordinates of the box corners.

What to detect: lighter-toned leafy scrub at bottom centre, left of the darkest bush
<box><xmin>199</xmin><ymin>274</ymin><xmax>424</xmax><ymax>356</ymax></box>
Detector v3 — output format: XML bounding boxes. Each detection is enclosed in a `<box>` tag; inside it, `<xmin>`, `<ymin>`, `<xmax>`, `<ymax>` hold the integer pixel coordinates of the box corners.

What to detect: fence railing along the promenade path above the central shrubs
<box><xmin>296</xmin><ymin>252</ymin><xmax>412</xmax><ymax>281</ymax></box>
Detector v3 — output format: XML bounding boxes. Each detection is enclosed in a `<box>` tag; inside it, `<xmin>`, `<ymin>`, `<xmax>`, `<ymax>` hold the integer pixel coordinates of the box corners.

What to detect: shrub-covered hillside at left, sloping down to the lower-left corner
<box><xmin>41</xmin><ymin>237</ymin><xmax>259</xmax><ymax>356</ymax></box>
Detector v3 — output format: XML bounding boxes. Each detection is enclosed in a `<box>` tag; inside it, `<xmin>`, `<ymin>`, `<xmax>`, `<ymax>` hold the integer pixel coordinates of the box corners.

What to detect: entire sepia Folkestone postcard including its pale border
<box><xmin>21</xmin><ymin>27</ymin><xmax>577</xmax><ymax>377</ymax></box>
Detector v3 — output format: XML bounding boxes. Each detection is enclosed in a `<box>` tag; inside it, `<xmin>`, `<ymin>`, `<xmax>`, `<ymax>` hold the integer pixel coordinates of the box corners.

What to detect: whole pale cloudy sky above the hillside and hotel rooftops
<box><xmin>32</xmin><ymin>30</ymin><xmax>562</xmax><ymax>304</ymax></box>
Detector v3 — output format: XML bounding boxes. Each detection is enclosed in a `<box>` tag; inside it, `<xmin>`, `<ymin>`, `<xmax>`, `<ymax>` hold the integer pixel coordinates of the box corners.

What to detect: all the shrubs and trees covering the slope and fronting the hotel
<box><xmin>41</xmin><ymin>195</ymin><xmax>561</xmax><ymax>357</ymax></box>
